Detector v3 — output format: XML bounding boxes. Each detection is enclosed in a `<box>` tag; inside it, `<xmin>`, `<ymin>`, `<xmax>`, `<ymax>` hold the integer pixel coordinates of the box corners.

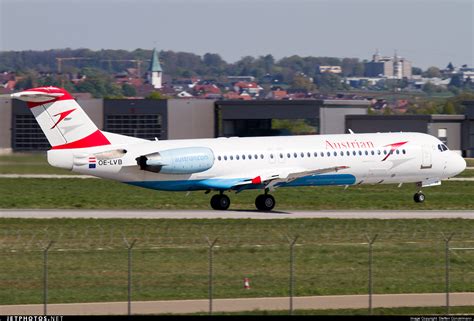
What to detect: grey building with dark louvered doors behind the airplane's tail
<box><xmin>0</xmin><ymin>98</ymin><xmax>215</xmax><ymax>153</ymax></box>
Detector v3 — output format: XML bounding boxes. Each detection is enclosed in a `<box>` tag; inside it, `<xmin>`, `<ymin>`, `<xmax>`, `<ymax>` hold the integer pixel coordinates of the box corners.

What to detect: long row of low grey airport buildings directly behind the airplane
<box><xmin>0</xmin><ymin>98</ymin><xmax>474</xmax><ymax>157</ymax></box>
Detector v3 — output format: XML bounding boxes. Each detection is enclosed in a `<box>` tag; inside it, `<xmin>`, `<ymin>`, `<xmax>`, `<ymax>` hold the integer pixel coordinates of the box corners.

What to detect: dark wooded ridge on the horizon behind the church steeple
<box><xmin>0</xmin><ymin>49</ymin><xmax>364</xmax><ymax>83</ymax></box>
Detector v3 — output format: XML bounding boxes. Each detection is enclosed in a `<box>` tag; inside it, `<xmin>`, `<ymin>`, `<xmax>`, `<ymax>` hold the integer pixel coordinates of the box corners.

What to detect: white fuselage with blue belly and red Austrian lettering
<box><xmin>48</xmin><ymin>133</ymin><xmax>465</xmax><ymax>191</ymax></box>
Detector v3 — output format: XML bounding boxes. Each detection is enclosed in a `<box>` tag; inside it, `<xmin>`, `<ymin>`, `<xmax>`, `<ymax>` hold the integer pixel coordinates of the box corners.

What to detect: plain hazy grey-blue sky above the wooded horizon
<box><xmin>0</xmin><ymin>0</ymin><xmax>474</xmax><ymax>68</ymax></box>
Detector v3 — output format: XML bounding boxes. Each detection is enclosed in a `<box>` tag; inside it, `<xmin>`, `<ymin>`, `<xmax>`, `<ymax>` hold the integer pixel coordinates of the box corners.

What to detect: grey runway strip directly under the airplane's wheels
<box><xmin>0</xmin><ymin>209</ymin><xmax>474</xmax><ymax>220</ymax></box>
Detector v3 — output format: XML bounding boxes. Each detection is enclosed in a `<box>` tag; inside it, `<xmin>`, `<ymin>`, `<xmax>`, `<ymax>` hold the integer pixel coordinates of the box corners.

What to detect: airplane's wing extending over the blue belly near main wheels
<box><xmin>233</xmin><ymin>166</ymin><xmax>349</xmax><ymax>189</ymax></box>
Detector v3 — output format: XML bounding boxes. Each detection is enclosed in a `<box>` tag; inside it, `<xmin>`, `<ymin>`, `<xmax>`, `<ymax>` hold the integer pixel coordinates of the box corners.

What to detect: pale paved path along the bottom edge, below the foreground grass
<box><xmin>0</xmin><ymin>292</ymin><xmax>474</xmax><ymax>315</ymax></box>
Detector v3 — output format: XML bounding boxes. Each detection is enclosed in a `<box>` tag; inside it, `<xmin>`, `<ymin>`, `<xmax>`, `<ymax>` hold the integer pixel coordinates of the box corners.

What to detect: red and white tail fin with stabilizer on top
<box><xmin>11</xmin><ymin>87</ymin><xmax>110</xmax><ymax>149</ymax></box>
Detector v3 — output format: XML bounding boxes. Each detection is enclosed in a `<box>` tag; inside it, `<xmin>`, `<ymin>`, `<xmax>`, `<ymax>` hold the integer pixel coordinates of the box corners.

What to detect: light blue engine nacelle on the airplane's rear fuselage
<box><xmin>136</xmin><ymin>147</ymin><xmax>214</xmax><ymax>174</ymax></box>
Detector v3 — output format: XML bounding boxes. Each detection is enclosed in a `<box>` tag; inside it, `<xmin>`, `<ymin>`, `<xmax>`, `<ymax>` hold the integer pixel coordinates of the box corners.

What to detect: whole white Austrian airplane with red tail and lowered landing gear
<box><xmin>11</xmin><ymin>87</ymin><xmax>466</xmax><ymax>211</ymax></box>
